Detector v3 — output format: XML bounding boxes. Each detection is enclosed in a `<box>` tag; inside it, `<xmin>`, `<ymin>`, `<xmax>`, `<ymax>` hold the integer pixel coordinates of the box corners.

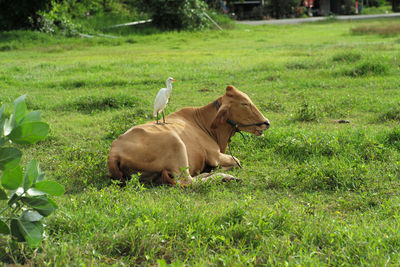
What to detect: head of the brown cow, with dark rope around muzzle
<box><xmin>211</xmin><ymin>85</ymin><xmax>269</xmax><ymax>136</ymax></box>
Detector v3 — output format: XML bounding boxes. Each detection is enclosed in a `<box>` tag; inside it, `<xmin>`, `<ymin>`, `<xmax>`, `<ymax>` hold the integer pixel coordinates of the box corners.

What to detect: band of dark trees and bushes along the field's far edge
<box><xmin>0</xmin><ymin>0</ymin><xmax>400</xmax><ymax>32</ymax></box>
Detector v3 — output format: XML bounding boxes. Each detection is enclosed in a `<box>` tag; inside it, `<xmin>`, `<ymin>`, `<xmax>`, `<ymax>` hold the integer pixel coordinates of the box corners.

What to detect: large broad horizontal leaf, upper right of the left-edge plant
<box><xmin>8</xmin><ymin>122</ymin><xmax>50</xmax><ymax>144</ymax></box>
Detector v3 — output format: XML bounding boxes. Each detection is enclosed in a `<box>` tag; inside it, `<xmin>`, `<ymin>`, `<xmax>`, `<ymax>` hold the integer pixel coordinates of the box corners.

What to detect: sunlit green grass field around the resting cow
<box><xmin>0</xmin><ymin>20</ymin><xmax>400</xmax><ymax>266</ymax></box>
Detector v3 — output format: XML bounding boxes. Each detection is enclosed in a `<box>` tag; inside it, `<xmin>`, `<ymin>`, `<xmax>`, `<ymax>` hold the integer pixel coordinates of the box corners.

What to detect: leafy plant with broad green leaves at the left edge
<box><xmin>0</xmin><ymin>95</ymin><xmax>64</xmax><ymax>248</ymax></box>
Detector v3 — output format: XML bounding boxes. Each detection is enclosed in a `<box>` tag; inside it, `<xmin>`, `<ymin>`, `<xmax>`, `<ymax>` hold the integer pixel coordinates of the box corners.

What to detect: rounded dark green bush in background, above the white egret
<box><xmin>138</xmin><ymin>0</ymin><xmax>208</xmax><ymax>30</ymax></box>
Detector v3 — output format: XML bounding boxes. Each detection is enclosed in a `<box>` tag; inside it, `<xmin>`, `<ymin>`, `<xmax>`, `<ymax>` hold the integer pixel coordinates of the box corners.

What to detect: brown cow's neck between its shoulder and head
<box><xmin>195</xmin><ymin>100</ymin><xmax>235</xmax><ymax>153</ymax></box>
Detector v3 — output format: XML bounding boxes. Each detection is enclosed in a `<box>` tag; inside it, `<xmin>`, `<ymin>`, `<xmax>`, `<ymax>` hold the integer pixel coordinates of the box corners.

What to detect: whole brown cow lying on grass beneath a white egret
<box><xmin>108</xmin><ymin>86</ymin><xmax>269</xmax><ymax>185</ymax></box>
